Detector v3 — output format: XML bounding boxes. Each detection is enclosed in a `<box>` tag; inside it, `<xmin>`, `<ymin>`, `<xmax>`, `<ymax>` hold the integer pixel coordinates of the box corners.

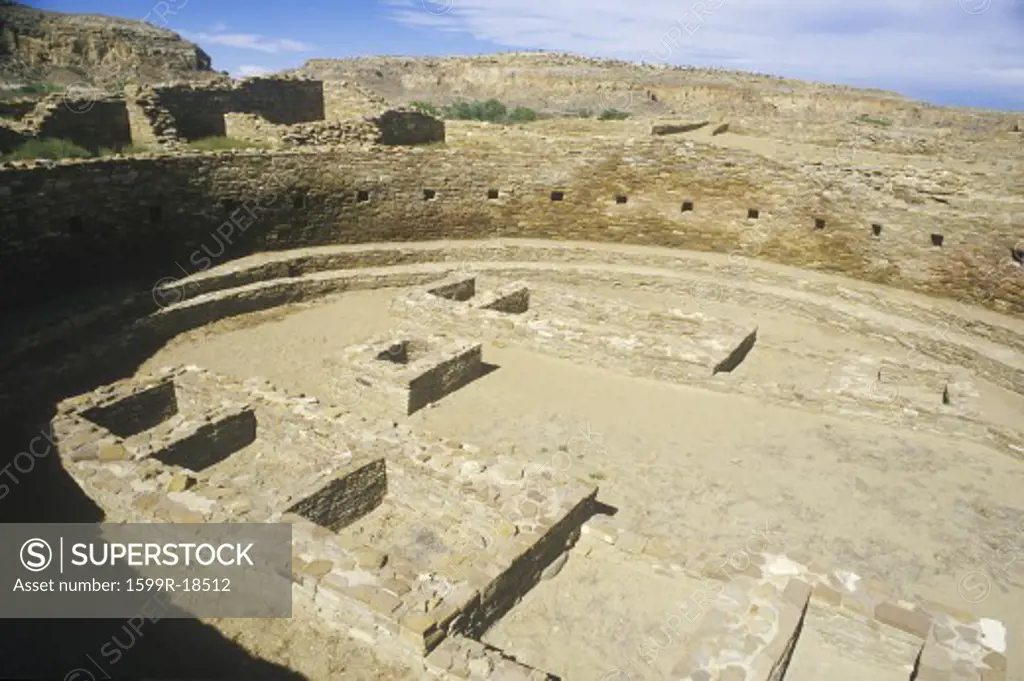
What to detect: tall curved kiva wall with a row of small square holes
<box><xmin>0</xmin><ymin>144</ymin><xmax>1024</xmax><ymax>313</ymax></box>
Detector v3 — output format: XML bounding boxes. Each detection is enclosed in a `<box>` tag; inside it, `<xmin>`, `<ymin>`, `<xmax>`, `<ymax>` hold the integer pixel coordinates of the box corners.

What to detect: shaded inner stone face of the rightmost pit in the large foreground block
<box><xmin>287</xmin><ymin>459</ymin><xmax>387</xmax><ymax>533</ymax></box>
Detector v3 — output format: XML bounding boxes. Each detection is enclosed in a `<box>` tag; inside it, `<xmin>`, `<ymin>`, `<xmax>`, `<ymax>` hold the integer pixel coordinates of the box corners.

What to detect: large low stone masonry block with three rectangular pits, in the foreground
<box><xmin>52</xmin><ymin>367</ymin><xmax>597</xmax><ymax>680</ymax></box>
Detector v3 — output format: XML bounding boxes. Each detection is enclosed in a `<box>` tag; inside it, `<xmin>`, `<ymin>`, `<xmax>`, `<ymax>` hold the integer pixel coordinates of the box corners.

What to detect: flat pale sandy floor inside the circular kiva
<box><xmin>143</xmin><ymin>274</ymin><xmax>1024</xmax><ymax>678</ymax></box>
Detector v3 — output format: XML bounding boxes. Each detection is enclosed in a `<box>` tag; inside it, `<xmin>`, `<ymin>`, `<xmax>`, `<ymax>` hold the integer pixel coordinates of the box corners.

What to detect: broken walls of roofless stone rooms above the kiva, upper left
<box><xmin>0</xmin><ymin>77</ymin><xmax>444</xmax><ymax>153</ymax></box>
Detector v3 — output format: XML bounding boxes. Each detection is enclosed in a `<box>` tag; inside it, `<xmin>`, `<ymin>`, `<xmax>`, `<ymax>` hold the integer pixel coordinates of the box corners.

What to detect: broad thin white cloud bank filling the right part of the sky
<box><xmin>386</xmin><ymin>0</ymin><xmax>1024</xmax><ymax>104</ymax></box>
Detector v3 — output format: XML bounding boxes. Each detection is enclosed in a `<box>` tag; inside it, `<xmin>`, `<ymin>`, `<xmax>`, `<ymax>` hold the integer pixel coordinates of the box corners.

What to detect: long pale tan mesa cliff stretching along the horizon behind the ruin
<box><xmin>288</xmin><ymin>52</ymin><xmax>1019</xmax><ymax>142</ymax></box>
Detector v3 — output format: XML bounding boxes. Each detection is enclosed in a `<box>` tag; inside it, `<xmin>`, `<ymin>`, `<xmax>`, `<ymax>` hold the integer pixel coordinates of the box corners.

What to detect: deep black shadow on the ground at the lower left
<box><xmin>0</xmin><ymin>282</ymin><xmax>305</xmax><ymax>681</ymax></box>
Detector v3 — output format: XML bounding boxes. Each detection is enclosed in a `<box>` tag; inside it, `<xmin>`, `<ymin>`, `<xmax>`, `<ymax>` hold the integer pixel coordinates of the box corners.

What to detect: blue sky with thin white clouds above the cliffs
<box><xmin>29</xmin><ymin>0</ymin><xmax>1024</xmax><ymax>110</ymax></box>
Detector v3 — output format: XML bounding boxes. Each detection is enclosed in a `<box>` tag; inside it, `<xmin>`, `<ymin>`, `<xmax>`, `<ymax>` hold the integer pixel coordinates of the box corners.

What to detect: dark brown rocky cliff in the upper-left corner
<box><xmin>0</xmin><ymin>0</ymin><xmax>216</xmax><ymax>85</ymax></box>
